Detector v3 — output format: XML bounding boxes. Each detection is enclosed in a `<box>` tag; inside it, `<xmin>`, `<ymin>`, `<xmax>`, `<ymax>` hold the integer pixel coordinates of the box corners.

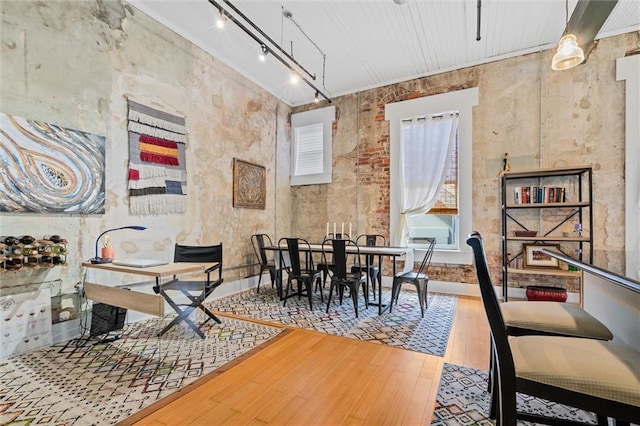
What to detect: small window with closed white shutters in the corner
<box><xmin>291</xmin><ymin>106</ymin><xmax>336</xmax><ymax>186</ymax></box>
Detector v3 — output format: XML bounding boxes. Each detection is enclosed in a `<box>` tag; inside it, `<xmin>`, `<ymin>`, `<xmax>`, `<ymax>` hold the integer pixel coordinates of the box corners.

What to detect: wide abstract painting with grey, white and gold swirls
<box><xmin>0</xmin><ymin>113</ymin><xmax>105</xmax><ymax>214</ymax></box>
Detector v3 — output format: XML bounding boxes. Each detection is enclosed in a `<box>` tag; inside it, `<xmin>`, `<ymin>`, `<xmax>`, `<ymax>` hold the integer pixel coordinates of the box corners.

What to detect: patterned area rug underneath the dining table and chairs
<box><xmin>211</xmin><ymin>288</ymin><xmax>457</xmax><ymax>356</ymax></box>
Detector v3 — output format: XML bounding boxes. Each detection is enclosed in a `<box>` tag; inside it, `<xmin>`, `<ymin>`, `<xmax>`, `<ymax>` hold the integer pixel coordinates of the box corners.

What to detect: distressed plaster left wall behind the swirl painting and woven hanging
<box><xmin>0</xmin><ymin>0</ymin><xmax>291</xmax><ymax>317</ymax></box>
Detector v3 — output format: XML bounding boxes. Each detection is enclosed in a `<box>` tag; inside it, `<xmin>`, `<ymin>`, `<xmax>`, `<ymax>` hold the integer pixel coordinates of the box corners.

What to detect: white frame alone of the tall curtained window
<box><xmin>385</xmin><ymin>87</ymin><xmax>479</xmax><ymax>265</ymax></box>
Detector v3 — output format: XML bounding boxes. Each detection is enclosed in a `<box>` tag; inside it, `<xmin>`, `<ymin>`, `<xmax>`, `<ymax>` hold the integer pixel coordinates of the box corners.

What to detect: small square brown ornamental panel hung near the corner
<box><xmin>233</xmin><ymin>158</ymin><xmax>267</xmax><ymax>210</ymax></box>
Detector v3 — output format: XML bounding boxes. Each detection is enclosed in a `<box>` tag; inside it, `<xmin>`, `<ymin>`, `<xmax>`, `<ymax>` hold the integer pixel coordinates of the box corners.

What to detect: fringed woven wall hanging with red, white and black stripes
<box><xmin>128</xmin><ymin>100</ymin><xmax>187</xmax><ymax>215</ymax></box>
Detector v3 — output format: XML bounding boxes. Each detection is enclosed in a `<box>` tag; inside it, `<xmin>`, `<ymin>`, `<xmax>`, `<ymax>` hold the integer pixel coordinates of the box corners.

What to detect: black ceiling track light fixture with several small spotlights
<box><xmin>208</xmin><ymin>0</ymin><xmax>331</xmax><ymax>103</ymax></box>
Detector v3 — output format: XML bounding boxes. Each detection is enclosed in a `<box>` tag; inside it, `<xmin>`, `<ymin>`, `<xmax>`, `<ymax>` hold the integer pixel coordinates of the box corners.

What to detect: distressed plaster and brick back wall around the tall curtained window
<box><xmin>293</xmin><ymin>32</ymin><xmax>640</xmax><ymax>288</ymax></box>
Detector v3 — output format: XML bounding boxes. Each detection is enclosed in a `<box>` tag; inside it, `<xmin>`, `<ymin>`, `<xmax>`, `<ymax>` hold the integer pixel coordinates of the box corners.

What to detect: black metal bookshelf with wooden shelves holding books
<box><xmin>501</xmin><ymin>166</ymin><xmax>593</xmax><ymax>301</ymax></box>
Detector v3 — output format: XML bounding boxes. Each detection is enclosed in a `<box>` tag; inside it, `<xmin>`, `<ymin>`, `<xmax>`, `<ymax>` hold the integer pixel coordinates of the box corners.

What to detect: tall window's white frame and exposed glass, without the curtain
<box><xmin>385</xmin><ymin>88</ymin><xmax>478</xmax><ymax>264</ymax></box>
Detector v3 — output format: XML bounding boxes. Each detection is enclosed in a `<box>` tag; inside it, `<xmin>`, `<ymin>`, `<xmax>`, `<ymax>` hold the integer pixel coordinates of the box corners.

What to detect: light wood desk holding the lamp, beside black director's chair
<box><xmin>82</xmin><ymin>262</ymin><xmax>207</xmax><ymax>330</ymax></box>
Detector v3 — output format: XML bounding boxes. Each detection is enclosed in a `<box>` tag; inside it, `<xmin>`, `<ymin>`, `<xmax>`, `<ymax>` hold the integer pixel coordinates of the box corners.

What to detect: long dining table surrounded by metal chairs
<box><xmin>265</xmin><ymin>244</ymin><xmax>413</xmax><ymax>315</ymax></box>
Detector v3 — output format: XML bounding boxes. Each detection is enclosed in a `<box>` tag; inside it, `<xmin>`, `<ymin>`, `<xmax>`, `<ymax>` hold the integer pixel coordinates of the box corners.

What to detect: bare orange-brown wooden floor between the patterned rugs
<box><xmin>134</xmin><ymin>297</ymin><xmax>489</xmax><ymax>426</ymax></box>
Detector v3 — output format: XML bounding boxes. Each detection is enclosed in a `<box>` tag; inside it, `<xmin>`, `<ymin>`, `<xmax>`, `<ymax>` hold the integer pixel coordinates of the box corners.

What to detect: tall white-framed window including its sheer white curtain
<box><xmin>385</xmin><ymin>87</ymin><xmax>479</xmax><ymax>265</ymax></box>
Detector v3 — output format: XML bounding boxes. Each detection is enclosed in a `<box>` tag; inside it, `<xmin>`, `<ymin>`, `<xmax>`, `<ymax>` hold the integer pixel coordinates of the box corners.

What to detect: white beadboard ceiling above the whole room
<box><xmin>128</xmin><ymin>0</ymin><xmax>640</xmax><ymax>105</ymax></box>
